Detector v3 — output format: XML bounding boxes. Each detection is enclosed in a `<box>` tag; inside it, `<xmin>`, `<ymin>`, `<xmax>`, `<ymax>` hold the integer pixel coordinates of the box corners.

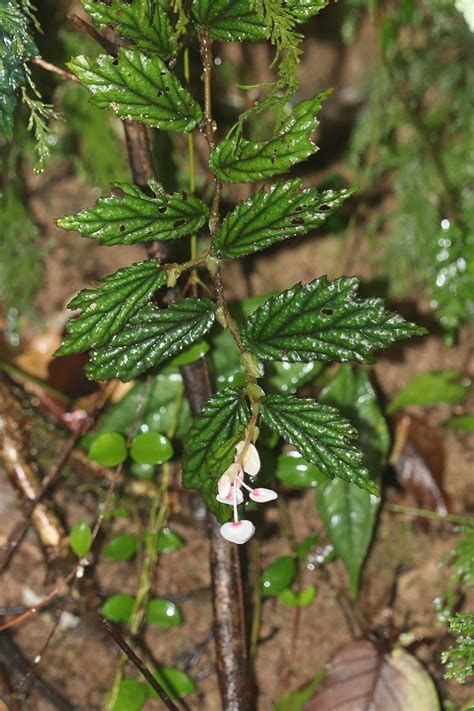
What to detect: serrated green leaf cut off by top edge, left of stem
<box><xmin>82</xmin><ymin>0</ymin><xmax>177</xmax><ymax>61</ymax></box>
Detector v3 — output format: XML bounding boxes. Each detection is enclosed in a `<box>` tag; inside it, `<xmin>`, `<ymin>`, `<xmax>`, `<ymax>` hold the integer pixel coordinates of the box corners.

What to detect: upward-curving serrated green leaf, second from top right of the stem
<box><xmin>209</xmin><ymin>93</ymin><xmax>327</xmax><ymax>183</ymax></box>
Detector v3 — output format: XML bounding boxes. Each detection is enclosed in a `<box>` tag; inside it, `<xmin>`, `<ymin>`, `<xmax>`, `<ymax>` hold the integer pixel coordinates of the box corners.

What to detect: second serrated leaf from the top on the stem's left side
<box><xmin>68</xmin><ymin>49</ymin><xmax>202</xmax><ymax>131</ymax></box>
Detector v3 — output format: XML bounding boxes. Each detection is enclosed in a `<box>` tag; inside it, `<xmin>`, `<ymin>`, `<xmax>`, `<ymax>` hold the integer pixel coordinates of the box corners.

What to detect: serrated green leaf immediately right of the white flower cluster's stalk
<box><xmin>261</xmin><ymin>395</ymin><xmax>380</xmax><ymax>496</ymax></box>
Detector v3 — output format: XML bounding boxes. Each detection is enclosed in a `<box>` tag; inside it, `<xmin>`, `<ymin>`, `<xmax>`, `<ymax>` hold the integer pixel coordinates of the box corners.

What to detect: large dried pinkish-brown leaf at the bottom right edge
<box><xmin>304</xmin><ymin>640</ymin><xmax>440</xmax><ymax>711</ymax></box>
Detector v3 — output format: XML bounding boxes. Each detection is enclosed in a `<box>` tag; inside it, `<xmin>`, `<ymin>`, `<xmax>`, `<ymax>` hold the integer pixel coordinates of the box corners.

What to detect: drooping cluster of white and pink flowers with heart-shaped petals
<box><xmin>216</xmin><ymin>441</ymin><xmax>278</xmax><ymax>543</ymax></box>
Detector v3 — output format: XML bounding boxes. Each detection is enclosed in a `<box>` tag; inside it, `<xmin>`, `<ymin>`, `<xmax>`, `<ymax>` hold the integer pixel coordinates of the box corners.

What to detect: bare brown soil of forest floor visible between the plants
<box><xmin>0</xmin><ymin>6</ymin><xmax>474</xmax><ymax>711</ymax></box>
